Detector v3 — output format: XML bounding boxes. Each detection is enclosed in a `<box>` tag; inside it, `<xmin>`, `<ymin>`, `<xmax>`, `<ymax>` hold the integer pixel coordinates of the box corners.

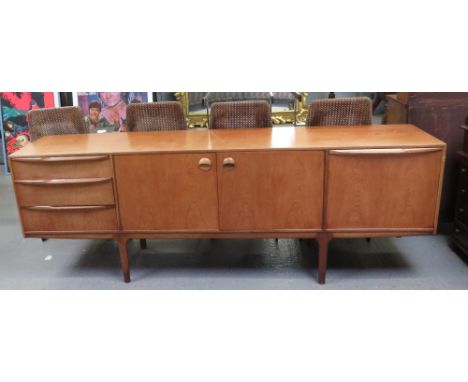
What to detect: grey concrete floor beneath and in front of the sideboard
<box><xmin>0</xmin><ymin>168</ymin><xmax>468</xmax><ymax>289</ymax></box>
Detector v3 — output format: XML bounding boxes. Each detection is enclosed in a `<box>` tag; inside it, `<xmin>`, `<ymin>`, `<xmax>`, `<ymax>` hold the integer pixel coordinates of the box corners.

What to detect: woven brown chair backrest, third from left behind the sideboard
<box><xmin>209</xmin><ymin>101</ymin><xmax>271</xmax><ymax>129</ymax></box>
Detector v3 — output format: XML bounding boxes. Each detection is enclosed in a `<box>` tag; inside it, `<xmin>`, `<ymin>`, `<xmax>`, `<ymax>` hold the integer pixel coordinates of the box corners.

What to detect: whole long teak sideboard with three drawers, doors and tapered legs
<box><xmin>9</xmin><ymin>125</ymin><xmax>445</xmax><ymax>283</ymax></box>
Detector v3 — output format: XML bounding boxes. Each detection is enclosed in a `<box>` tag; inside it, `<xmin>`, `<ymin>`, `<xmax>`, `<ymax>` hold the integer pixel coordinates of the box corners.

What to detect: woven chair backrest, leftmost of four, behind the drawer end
<box><xmin>28</xmin><ymin>106</ymin><xmax>89</xmax><ymax>141</ymax></box>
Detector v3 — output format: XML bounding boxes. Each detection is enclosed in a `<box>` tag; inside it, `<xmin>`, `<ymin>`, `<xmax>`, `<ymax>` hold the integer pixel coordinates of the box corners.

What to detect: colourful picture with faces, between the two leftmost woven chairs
<box><xmin>73</xmin><ymin>92</ymin><xmax>153</xmax><ymax>133</ymax></box>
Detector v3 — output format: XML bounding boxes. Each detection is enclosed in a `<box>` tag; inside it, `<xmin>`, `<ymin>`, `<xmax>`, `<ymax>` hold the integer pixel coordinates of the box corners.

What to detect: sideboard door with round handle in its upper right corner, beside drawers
<box><xmin>115</xmin><ymin>154</ymin><xmax>218</xmax><ymax>231</ymax></box>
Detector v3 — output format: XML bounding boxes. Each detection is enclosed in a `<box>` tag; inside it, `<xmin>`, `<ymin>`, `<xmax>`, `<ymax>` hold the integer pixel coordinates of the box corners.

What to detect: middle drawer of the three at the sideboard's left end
<box><xmin>15</xmin><ymin>178</ymin><xmax>115</xmax><ymax>206</ymax></box>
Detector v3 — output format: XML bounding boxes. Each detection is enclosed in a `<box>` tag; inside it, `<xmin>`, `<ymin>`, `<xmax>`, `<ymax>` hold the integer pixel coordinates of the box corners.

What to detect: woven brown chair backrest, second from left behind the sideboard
<box><xmin>127</xmin><ymin>101</ymin><xmax>187</xmax><ymax>131</ymax></box>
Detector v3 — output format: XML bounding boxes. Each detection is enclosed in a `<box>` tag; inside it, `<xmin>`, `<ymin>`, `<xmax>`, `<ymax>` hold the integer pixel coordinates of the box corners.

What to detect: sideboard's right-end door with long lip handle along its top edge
<box><xmin>325</xmin><ymin>148</ymin><xmax>443</xmax><ymax>231</ymax></box>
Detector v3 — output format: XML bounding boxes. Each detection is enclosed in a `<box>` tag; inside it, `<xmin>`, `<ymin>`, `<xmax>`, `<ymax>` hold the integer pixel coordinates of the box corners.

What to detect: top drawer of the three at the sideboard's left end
<box><xmin>11</xmin><ymin>155</ymin><xmax>112</xmax><ymax>180</ymax></box>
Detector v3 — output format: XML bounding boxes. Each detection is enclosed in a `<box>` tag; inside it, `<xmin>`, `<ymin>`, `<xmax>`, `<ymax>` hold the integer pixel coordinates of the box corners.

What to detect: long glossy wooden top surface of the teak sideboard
<box><xmin>10</xmin><ymin>125</ymin><xmax>445</xmax><ymax>158</ymax></box>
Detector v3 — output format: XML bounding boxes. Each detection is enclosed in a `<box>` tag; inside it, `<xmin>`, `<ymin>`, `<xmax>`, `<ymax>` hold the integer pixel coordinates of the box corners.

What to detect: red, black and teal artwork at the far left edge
<box><xmin>0</xmin><ymin>92</ymin><xmax>60</xmax><ymax>173</ymax></box>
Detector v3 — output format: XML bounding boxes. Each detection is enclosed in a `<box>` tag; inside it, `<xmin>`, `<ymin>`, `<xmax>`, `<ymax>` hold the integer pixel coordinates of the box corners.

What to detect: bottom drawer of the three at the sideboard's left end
<box><xmin>21</xmin><ymin>206</ymin><xmax>117</xmax><ymax>232</ymax></box>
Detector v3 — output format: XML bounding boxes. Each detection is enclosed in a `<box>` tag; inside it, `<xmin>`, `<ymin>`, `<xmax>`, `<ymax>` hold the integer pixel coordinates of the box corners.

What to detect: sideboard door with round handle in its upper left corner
<box><xmin>217</xmin><ymin>150</ymin><xmax>324</xmax><ymax>231</ymax></box>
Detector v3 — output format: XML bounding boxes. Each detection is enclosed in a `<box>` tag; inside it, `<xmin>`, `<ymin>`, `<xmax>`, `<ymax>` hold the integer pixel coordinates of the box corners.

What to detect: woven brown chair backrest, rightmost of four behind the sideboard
<box><xmin>306</xmin><ymin>97</ymin><xmax>372</xmax><ymax>126</ymax></box>
